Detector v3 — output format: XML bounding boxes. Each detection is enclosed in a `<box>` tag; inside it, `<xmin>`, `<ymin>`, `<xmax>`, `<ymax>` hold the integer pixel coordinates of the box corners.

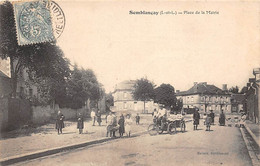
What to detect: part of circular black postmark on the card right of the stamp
<box><xmin>46</xmin><ymin>1</ymin><xmax>65</xmax><ymax>39</ymax></box>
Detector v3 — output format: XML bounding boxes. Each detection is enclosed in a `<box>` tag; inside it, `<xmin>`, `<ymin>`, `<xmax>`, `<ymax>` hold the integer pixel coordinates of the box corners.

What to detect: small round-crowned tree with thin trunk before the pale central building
<box><xmin>133</xmin><ymin>78</ymin><xmax>155</xmax><ymax>113</ymax></box>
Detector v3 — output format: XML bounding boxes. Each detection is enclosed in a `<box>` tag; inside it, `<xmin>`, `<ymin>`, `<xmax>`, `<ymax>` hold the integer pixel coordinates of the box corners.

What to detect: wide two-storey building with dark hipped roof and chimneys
<box><xmin>176</xmin><ymin>82</ymin><xmax>231</xmax><ymax>113</ymax></box>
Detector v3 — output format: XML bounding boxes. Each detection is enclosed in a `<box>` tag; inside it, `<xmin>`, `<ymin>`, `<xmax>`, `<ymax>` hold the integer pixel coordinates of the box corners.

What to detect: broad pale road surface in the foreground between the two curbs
<box><xmin>13</xmin><ymin>123</ymin><xmax>252</xmax><ymax>166</ymax></box>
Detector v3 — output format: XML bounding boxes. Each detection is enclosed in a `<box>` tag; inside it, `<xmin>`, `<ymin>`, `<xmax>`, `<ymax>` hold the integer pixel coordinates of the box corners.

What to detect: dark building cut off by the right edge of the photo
<box><xmin>245</xmin><ymin>68</ymin><xmax>260</xmax><ymax>123</ymax></box>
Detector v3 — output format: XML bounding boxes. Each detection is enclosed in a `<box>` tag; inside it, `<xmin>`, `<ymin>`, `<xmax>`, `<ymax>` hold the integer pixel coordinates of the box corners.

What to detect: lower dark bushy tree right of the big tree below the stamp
<box><xmin>67</xmin><ymin>65</ymin><xmax>102</xmax><ymax>109</ymax></box>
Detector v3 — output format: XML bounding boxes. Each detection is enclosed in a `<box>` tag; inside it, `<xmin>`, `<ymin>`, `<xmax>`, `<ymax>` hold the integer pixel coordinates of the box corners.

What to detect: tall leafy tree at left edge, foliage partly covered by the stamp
<box><xmin>0</xmin><ymin>1</ymin><xmax>68</xmax><ymax>97</ymax></box>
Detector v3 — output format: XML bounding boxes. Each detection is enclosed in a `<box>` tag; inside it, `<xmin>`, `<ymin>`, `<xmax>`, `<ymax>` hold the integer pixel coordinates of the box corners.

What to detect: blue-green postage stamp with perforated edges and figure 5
<box><xmin>14</xmin><ymin>0</ymin><xmax>55</xmax><ymax>45</ymax></box>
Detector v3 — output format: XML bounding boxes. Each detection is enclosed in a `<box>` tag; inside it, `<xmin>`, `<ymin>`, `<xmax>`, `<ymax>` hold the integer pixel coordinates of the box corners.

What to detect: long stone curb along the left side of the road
<box><xmin>0</xmin><ymin>131</ymin><xmax>147</xmax><ymax>166</ymax></box>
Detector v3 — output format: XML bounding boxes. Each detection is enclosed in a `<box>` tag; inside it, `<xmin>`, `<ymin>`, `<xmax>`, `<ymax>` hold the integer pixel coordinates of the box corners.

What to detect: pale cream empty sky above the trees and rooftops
<box><xmin>53</xmin><ymin>1</ymin><xmax>260</xmax><ymax>92</ymax></box>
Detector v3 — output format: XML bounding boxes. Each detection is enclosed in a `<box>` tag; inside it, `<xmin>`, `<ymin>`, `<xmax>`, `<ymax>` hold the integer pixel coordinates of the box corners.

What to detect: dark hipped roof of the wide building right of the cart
<box><xmin>176</xmin><ymin>83</ymin><xmax>228</xmax><ymax>96</ymax></box>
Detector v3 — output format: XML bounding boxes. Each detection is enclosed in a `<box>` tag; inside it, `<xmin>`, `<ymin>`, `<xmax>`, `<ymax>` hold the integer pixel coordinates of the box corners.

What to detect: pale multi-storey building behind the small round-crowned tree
<box><xmin>113</xmin><ymin>80</ymin><xmax>159</xmax><ymax>113</ymax></box>
